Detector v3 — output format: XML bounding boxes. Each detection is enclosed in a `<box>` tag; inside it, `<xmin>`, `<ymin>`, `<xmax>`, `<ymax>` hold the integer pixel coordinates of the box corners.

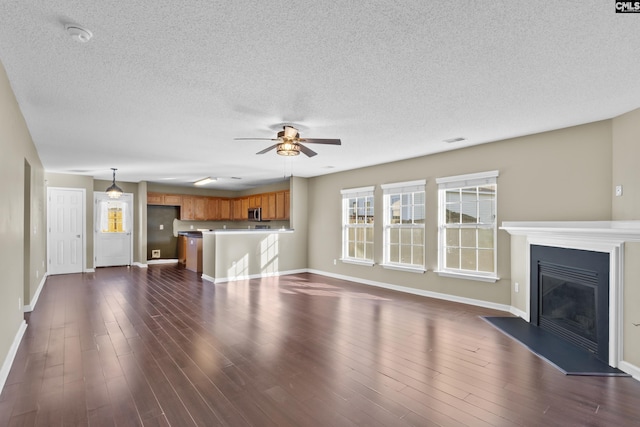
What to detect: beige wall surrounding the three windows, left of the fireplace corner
<box><xmin>308</xmin><ymin>121</ymin><xmax>612</xmax><ymax>305</ymax></box>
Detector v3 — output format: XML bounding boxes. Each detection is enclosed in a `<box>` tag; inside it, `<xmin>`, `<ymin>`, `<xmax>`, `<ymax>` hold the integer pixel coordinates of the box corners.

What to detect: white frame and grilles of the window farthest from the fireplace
<box><xmin>340</xmin><ymin>186</ymin><xmax>375</xmax><ymax>266</ymax></box>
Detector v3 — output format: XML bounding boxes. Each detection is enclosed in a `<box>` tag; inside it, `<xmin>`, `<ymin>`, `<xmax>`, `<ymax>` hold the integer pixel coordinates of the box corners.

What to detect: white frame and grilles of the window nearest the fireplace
<box><xmin>436</xmin><ymin>170</ymin><xmax>499</xmax><ymax>282</ymax></box>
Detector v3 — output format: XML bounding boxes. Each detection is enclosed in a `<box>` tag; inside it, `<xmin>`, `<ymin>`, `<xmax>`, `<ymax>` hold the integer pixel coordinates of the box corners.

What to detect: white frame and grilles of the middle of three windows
<box><xmin>380</xmin><ymin>179</ymin><xmax>427</xmax><ymax>273</ymax></box>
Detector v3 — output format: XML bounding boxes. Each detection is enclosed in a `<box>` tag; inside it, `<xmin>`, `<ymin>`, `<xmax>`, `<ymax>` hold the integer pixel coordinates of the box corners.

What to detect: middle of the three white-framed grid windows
<box><xmin>382</xmin><ymin>180</ymin><xmax>426</xmax><ymax>272</ymax></box>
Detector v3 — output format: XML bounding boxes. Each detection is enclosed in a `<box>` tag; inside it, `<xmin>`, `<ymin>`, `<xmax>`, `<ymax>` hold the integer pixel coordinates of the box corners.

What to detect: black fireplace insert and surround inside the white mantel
<box><xmin>530</xmin><ymin>245</ymin><xmax>609</xmax><ymax>363</ymax></box>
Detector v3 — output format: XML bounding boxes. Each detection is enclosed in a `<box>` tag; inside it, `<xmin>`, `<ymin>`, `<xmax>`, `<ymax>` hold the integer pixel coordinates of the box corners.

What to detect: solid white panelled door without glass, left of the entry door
<box><xmin>47</xmin><ymin>188</ymin><xmax>86</xmax><ymax>274</ymax></box>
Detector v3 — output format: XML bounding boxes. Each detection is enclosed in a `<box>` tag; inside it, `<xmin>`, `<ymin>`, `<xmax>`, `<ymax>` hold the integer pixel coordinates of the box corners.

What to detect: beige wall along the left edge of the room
<box><xmin>0</xmin><ymin>63</ymin><xmax>46</xmax><ymax>372</ymax></box>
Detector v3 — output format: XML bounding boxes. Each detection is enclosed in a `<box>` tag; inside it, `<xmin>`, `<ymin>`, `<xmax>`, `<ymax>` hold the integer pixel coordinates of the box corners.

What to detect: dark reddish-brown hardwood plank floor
<box><xmin>0</xmin><ymin>265</ymin><xmax>640</xmax><ymax>427</ymax></box>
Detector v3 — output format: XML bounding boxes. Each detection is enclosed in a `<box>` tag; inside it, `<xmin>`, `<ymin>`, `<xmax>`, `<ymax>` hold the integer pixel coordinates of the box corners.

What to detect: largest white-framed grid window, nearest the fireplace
<box><xmin>436</xmin><ymin>171</ymin><xmax>498</xmax><ymax>281</ymax></box>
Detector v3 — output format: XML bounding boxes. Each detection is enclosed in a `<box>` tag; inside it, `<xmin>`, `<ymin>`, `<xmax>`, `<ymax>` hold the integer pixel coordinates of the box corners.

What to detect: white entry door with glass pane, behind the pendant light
<box><xmin>93</xmin><ymin>191</ymin><xmax>133</xmax><ymax>267</ymax></box>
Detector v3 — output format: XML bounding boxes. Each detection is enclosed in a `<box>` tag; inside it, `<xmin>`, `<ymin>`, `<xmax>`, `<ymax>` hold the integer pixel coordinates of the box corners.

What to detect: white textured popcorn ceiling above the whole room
<box><xmin>0</xmin><ymin>0</ymin><xmax>640</xmax><ymax>189</ymax></box>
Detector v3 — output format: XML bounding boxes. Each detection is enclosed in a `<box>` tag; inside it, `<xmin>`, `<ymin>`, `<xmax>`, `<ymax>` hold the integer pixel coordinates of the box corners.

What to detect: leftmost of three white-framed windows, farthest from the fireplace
<box><xmin>341</xmin><ymin>187</ymin><xmax>374</xmax><ymax>265</ymax></box>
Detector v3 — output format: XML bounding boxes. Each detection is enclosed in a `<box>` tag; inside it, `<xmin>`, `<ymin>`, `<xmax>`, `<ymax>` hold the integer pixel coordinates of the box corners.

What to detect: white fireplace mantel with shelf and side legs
<box><xmin>500</xmin><ymin>221</ymin><xmax>640</xmax><ymax>370</ymax></box>
